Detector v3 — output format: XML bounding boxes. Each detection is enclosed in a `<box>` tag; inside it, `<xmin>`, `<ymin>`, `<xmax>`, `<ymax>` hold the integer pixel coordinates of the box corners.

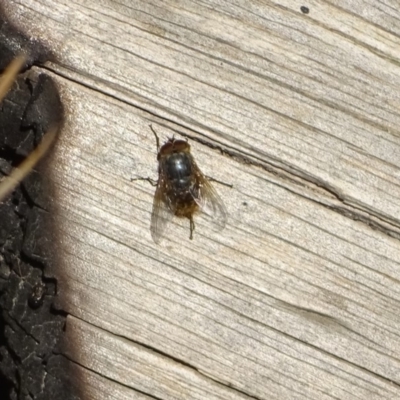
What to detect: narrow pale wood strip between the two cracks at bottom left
<box><xmin>66</xmin><ymin>317</ymin><xmax>256</xmax><ymax>400</ymax></box>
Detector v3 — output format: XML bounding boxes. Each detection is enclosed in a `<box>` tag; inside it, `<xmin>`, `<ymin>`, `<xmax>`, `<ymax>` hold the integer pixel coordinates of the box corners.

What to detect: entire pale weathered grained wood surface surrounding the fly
<box><xmin>3</xmin><ymin>0</ymin><xmax>400</xmax><ymax>400</ymax></box>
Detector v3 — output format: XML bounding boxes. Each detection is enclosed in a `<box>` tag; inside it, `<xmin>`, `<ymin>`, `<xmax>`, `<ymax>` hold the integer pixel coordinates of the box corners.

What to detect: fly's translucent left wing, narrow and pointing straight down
<box><xmin>150</xmin><ymin>174</ymin><xmax>174</xmax><ymax>243</ymax></box>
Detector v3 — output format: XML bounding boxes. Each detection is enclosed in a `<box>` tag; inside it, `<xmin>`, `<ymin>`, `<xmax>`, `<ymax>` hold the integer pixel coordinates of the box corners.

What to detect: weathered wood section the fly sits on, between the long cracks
<box><xmin>44</xmin><ymin>76</ymin><xmax>400</xmax><ymax>399</ymax></box>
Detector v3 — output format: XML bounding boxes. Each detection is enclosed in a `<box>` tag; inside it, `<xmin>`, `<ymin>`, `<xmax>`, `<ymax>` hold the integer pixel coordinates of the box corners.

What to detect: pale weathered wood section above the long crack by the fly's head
<box><xmin>10</xmin><ymin>0</ymin><xmax>400</xmax><ymax>225</ymax></box>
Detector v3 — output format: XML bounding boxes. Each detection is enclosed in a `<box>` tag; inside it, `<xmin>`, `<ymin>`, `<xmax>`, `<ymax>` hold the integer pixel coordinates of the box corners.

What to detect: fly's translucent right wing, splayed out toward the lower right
<box><xmin>190</xmin><ymin>161</ymin><xmax>227</xmax><ymax>229</ymax></box>
